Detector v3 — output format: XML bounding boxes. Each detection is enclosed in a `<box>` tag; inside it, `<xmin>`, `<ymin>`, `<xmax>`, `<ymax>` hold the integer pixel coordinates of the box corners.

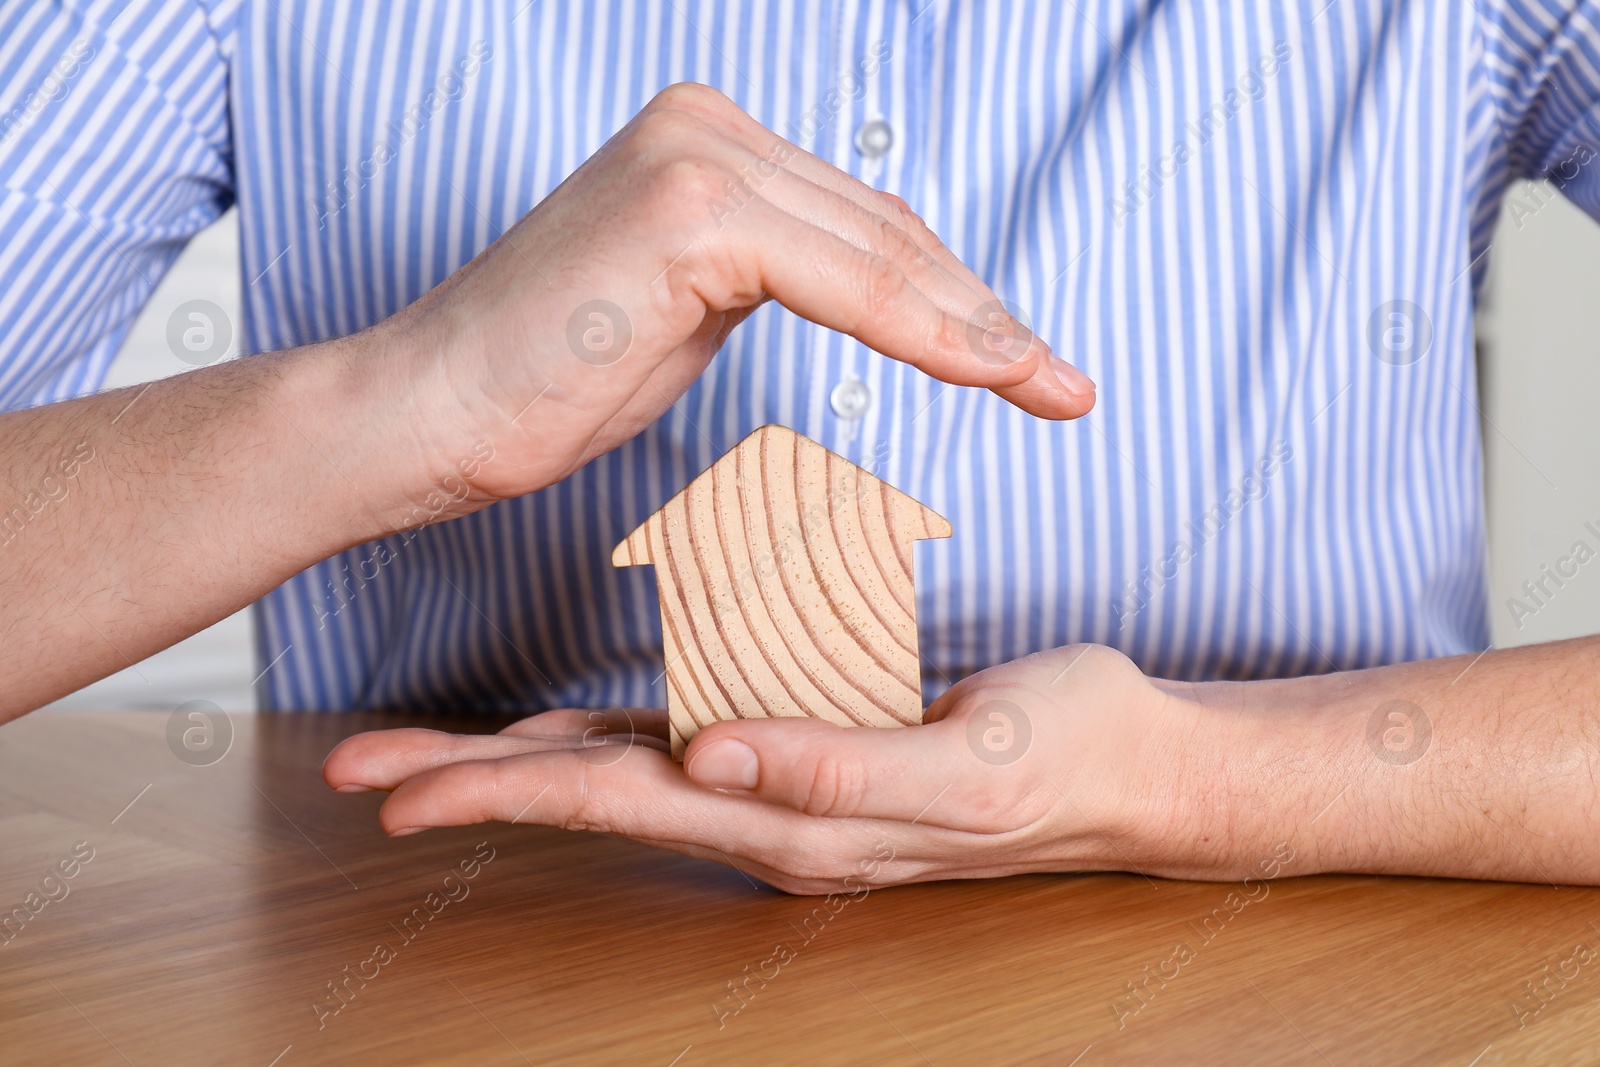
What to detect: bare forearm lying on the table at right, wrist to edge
<box><xmin>1171</xmin><ymin>638</ymin><xmax>1600</xmax><ymax>885</ymax></box>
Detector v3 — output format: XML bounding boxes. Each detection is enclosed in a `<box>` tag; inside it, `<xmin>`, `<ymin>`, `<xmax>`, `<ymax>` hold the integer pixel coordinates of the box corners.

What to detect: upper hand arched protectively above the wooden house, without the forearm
<box><xmin>390</xmin><ymin>85</ymin><xmax>1094</xmax><ymax>510</ymax></box>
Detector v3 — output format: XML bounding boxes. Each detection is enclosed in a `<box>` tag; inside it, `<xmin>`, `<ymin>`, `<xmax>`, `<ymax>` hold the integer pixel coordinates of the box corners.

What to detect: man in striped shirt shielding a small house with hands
<box><xmin>0</xmin><ymin>0</ymin><xmax>1600</xmax><ymax>891</ymax></box>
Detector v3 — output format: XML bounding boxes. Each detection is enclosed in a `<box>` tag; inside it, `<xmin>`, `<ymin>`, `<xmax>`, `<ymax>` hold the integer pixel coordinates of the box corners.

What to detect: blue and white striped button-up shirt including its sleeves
<box><xmin>0</xmin><ymin>0</ymin><xmax>1600</xmax><ymax>709</ymax></box>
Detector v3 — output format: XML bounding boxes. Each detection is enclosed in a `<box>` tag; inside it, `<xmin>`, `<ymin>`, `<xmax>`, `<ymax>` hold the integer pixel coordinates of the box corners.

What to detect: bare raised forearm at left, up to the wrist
<box><xmin>0</xmin><ymin>316</ymin><xmax>444</xmax><ymax>721</ymax></box>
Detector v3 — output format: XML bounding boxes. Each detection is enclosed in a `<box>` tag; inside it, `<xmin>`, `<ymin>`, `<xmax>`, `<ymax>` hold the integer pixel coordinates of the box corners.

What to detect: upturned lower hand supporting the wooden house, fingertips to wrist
<box><xmin>323</xmin><ymin>646</ymin><xmax>1195</xmax><ymax>893</ymax></box>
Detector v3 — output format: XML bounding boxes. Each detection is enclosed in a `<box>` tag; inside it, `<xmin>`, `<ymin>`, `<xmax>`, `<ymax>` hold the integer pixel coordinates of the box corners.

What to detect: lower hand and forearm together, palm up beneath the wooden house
<box><xmin>323</xmin><ymin>638</ymin><xmax>1600</xmax><ymax>893</ymax></box>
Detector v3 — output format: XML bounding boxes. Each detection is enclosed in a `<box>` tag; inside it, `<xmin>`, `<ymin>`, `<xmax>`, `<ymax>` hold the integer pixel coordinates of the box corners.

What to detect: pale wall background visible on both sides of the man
<box><xmin>43</xmin><ymin>182</ymin><xmax>1600</xmax><ymax>712</ymax></box>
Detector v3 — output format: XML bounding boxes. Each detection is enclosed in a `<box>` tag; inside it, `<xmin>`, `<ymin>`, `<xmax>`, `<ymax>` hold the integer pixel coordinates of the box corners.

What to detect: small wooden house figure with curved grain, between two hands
<box><xmin>611</xmin><ymin>426</ymin><xmax>950</xmax><ymax>760</ymax></box>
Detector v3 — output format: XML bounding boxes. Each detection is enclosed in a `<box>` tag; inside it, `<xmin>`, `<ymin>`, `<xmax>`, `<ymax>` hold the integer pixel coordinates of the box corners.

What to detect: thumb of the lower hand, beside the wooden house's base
<box><xmin>683</xmin><ymin>717</ymin><xmax>1034</xmax><ymax>832</ymax></box>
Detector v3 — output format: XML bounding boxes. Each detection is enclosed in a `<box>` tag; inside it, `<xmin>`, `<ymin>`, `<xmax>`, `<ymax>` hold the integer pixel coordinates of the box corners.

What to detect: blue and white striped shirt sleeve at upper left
<box><xmin>0</xmin><ymin>0</ymin><xmax>234</xmax><ymax>410</ymax></box>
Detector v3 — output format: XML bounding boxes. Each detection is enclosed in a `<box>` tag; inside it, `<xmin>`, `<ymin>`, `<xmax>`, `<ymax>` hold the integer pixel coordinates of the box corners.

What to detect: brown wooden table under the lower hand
<box><xmin>0</xmin><ymin>713</ymin><xmax>1600</xmax><ymax>1067</ymax></box>
